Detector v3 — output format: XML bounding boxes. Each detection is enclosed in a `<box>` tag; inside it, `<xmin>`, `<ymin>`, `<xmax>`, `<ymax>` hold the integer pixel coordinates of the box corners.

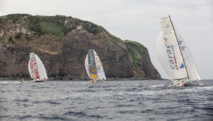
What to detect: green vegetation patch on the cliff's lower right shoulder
<box><xmin>123</xmin><ymin>40</ymin><xmax>147</xmax><ymax>67</ymax></box>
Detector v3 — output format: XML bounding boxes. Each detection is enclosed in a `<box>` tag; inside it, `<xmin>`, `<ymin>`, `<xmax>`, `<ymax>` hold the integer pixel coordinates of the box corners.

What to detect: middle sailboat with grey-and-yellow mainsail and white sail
<box><xmin>85</xmin><ymin>49</ymin><xmax>106</xmax><ymax>83</ymax></box>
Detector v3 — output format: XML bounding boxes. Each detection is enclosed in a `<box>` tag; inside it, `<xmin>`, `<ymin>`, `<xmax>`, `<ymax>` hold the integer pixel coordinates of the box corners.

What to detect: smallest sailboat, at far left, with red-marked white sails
<box><xmin>28</xmin><ymin>52</ymin><xmax>48</xmax><ymax>82</ymax></box>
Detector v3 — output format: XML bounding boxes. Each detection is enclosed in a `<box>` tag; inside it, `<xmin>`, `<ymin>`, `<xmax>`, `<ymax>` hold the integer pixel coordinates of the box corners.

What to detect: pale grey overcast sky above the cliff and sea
<box><xmin>0</xmin><ymin>0</ymin><xmax>213</xmax><ymax>79</ymax></box>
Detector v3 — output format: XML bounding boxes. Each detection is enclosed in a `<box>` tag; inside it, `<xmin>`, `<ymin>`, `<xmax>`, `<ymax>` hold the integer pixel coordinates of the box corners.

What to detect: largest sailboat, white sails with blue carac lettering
<box><xmin>156</xmin><ymin>16</ymin><xmax>201</xmax><ymax>86</ymax></box>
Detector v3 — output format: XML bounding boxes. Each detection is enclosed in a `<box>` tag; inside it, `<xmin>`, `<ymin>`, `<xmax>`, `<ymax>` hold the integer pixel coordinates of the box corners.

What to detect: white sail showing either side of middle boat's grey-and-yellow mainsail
<box><xmin>85</xmin><ymin>50</ymin><xmax>106</xmax><ymax>80</ymax></box>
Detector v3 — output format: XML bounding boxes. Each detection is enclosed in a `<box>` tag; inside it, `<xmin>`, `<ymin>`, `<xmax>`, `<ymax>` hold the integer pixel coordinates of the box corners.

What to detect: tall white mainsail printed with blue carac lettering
<box><xmin>161</xmin><ymin>17</ymin><xmax>188</xmax><ymax>80</ymax></box>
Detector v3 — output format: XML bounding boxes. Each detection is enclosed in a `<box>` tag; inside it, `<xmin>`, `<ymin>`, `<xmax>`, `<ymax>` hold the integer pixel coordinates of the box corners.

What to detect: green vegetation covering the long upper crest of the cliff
<box><xmin>0</xmin><ymin>14</ymin><xmax>121</xmax><ymax>42</ymax></box>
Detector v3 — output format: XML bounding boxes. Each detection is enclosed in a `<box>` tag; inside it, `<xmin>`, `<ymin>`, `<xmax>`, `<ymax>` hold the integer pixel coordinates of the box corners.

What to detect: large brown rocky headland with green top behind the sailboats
<box><xmin>0</xmin><ymin>14</ymin><xmax>160</xmax><ymax>80</ymax></box>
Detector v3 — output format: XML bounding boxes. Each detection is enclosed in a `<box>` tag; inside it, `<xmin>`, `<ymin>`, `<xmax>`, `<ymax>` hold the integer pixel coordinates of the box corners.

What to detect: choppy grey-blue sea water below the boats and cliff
<box><xmin>0</xmin><ymin>80</ymin><xmax>213</xmax><ymax>121</ymax></box>
